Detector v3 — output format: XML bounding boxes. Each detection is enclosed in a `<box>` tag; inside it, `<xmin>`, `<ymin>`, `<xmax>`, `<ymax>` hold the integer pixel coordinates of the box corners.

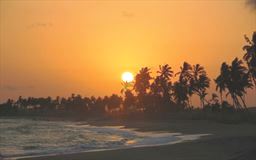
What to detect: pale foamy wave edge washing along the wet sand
<box><xmin>1</xmin><ymin>117</ymin><xmax>210</xmax><ymax>159</ymax></box>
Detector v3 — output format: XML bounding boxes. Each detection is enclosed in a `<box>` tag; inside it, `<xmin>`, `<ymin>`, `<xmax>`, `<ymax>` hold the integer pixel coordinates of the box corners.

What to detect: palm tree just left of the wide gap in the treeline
<box><xmin>190</xmin><ymin>64</ymin><xmax>210</xmax><ymax>108</ymax></box>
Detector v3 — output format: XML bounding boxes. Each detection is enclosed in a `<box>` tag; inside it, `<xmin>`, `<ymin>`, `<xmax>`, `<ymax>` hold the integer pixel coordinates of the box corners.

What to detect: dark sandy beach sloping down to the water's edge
<box><xmin>19</xmin><ymin>120</ymin><xmax>256</xmax><ymax>160</ymax></box>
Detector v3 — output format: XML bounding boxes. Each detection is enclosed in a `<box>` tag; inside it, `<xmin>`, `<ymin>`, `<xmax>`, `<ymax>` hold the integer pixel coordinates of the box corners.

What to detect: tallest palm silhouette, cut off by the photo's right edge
<box><xmin>243</xmin><ymin>32</ymin><xmax>256</xmax><ymax>88</ymax></box>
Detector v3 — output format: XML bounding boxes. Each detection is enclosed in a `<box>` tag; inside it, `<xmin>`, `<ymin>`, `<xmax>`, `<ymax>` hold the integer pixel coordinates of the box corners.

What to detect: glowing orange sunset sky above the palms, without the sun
<box><xmin>0</xmin><ymin>0</ymin><xmax>256</xmax><ymax>106</ymax></box>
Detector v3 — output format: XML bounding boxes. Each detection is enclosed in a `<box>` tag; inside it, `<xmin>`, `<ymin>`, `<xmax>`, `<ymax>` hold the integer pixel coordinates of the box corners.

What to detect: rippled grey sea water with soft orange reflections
<box><xmin>0</xmin><ymin>118</ymin><xmax>208</xmax><ymax>159</ymax></box>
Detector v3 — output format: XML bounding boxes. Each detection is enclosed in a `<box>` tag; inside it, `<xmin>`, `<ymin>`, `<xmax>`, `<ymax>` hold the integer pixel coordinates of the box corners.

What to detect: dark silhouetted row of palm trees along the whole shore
<box><xmin>0</xmin><ymin>32</ymin><xmax>256</xmax><ymax>115</ymax></box>
